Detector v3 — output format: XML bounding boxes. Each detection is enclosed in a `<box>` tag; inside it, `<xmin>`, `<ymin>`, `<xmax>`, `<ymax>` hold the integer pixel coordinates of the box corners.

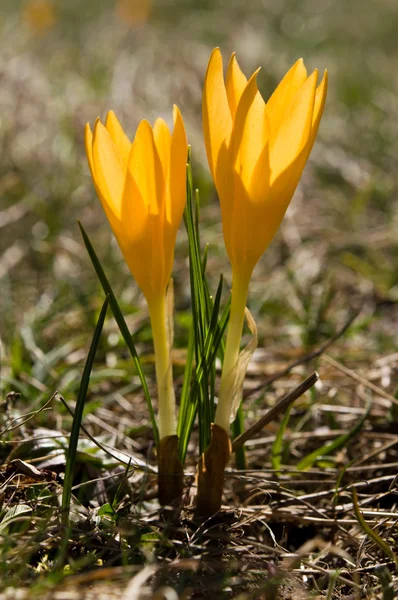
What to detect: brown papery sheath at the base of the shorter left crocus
<box><xmin>158</xmin><ymin>435</ymin><xmax>184</xmax><ymax>506</ymax></box>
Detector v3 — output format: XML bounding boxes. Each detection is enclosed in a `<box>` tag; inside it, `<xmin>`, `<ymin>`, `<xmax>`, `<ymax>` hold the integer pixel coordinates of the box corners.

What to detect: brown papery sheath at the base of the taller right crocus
<box><xmin>196</xmin><ymin>425</ymin><xmax>231</xmax><ymax>517</ymax></box>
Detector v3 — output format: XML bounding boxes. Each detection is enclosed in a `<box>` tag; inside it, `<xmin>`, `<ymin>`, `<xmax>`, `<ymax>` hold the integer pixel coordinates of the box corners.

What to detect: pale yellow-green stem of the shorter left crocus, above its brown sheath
<box><xmin>148</xmin><ymin>294</ymin><xmax>177</xmax><ymax>440</ymax></box>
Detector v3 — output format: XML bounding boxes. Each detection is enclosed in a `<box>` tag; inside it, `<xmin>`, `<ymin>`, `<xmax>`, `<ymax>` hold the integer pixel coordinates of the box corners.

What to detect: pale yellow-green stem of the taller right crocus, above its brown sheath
<box><xmin>214</xmin><ymin>271</ymin><xmax>251</xmax><ymax>434</ymax></box>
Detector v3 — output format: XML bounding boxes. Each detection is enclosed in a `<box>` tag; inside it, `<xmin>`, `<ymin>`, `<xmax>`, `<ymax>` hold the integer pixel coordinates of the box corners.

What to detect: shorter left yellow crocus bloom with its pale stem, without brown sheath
<box><xmin>85</xmin><ymin>106</ymin><xmax>188</xmax><ymax>440</ymax></box>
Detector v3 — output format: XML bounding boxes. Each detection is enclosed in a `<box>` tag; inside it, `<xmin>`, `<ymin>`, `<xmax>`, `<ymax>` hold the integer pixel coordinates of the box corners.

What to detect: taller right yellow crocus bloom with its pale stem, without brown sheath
<box><xmin>202</xmin><ymin>48</ymin><xmax>327</xmax><ymax>438</ymax></box>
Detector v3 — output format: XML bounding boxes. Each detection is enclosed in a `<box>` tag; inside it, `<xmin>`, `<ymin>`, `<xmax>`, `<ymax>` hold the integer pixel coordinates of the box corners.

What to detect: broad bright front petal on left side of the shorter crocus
<box><xmin>93</xmin><ymin>120</ymin><xmax>125</xmax><ymax>219</ymax></box>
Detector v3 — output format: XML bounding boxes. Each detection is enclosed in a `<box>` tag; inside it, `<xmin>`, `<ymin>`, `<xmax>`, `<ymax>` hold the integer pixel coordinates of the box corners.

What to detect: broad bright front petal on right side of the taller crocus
<box><xmin>270</xmin><ymin>70</ymin><xmax>318</xmax><ymax>185</ymax></box>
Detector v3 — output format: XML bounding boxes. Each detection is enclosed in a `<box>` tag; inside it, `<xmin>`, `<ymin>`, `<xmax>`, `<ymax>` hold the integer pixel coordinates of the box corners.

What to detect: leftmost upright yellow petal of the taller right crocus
<box><xmin>202</xmin><ymin>48</ymin><xmax>232</xmax><ymax>178</ymax></box>
